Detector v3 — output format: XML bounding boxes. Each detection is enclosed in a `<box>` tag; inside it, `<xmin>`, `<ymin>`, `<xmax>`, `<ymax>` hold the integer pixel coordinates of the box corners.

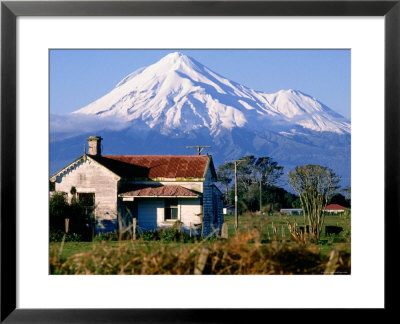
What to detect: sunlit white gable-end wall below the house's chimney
<box><xmin>55</xmin><ymin>159</ymin><xmax>118</xmax><ymax>234</ymax></box>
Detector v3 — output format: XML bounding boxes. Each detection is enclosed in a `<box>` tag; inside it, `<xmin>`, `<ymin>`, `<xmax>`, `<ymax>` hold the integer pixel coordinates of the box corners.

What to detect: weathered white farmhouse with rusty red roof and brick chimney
<box><xmin>50</xmin><ymin>136</ymin><xmax>223</xmax><ymax>236</ymax></box>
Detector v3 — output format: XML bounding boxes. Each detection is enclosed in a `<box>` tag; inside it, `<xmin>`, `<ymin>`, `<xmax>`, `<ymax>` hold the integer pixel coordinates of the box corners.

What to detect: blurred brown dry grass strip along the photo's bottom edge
<box><xmin>50</xmin><ymin>229</ymin><xmax>350</xmax><ymax>274</ymax></box>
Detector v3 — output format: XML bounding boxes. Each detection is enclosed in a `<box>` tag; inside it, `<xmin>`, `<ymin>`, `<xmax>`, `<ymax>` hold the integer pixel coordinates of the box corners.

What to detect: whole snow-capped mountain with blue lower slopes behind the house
<box><xmin>50</xmin><ymin>53</ymin><xmax>351</xmax><ymax>185</ymax></box>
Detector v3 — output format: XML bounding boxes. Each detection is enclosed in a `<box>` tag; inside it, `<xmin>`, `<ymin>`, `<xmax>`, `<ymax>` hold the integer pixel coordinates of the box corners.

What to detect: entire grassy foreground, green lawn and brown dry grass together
<box><xmin>49</xmin><ymin>216</ymin><xmax>351</xmax><ymax>274</ymax></box>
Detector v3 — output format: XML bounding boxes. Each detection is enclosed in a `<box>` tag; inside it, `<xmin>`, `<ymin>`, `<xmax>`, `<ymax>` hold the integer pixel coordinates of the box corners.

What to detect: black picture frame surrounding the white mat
<box><xmin>0</xmin><ymin>0</ymin><xmax>400</xmax><ymax>323</ymax></box>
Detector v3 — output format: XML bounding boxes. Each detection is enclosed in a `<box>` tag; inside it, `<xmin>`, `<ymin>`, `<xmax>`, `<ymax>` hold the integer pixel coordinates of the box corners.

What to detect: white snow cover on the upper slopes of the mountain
<box><xmin>74</xmin><ymin>52</ymin><xmax>350</xmax><ymax>136</ymax></box>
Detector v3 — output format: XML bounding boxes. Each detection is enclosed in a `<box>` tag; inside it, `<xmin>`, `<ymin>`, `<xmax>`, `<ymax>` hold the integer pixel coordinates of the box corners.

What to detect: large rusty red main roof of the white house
<box><xmin>90</xmin><ymin>155</ymin><xmax>215</xmax><ymax>179</ymax></box>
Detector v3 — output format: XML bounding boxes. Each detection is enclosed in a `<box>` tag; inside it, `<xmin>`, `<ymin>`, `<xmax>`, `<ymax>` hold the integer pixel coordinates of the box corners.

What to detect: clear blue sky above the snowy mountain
<box><xmin>50</xmin><ymin>49</ymin><xmax>351</xmax><ymax>118</ymax></box>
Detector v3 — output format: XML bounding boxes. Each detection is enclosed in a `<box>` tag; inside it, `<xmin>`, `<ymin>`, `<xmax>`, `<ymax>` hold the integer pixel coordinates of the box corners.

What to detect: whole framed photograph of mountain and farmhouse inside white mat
<box><xmin>48</xmin><ymin>48</ymin><xmax>351</xmax><ymax>275</ymax></box>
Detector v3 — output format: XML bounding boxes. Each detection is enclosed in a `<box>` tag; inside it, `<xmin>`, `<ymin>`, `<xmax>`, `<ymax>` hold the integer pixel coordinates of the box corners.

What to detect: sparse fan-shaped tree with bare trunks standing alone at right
<box><xmin>288</xmin><ymin>164</ymin><xmax>340</xmax><ymax>242</ymax></box>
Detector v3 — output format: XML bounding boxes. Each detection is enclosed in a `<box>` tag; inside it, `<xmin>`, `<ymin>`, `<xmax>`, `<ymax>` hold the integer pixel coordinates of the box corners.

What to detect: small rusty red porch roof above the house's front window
<box><xmin>120</xmin><ymin>185</ymin><xmax>199</xmax><ymax>198</ymax></box>
